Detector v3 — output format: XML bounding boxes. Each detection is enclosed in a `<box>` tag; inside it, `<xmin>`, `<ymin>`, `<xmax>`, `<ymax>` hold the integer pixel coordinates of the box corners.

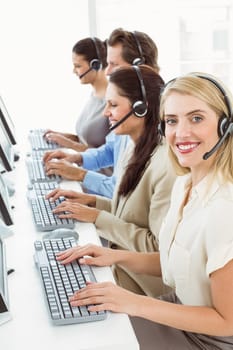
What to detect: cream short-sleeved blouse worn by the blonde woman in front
<box><xmin>159</xmin><ymin>174</ymin><xmax>233</xmax><ymax>306</ymax></box>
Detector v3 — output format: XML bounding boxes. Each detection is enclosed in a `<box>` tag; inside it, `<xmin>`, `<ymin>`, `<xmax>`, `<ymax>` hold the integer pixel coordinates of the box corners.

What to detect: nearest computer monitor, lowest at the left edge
<box><xmin>0</xmin><ymin>236</ymin><xmax>11</xmax><ymax>325</ymax></box>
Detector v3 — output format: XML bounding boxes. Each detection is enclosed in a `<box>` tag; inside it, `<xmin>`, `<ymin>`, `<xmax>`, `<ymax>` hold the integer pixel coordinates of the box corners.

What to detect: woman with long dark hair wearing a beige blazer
<box><xmin>48</xmin><ymin>66</ymin><xmax>175</xmax><ymax>296</ymax></box>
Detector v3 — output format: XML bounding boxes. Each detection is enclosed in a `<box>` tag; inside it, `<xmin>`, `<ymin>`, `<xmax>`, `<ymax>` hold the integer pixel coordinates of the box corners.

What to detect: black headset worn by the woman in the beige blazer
<box><xmin>109</xmin><ymin>65</ymin><xmax>148</xmax><ymax>131</ymax></box>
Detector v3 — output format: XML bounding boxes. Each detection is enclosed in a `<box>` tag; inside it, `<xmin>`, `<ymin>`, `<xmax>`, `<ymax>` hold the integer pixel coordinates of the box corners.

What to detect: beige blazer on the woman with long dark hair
<box><xmin>95</xmin><ymin>144</ymin><xmax>176</xmax><ymax>296</ymax></box>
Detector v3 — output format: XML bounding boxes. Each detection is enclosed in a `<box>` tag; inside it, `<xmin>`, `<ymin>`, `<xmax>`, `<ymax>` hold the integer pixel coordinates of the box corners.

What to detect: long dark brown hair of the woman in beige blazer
<box><xmin>109</xmin><ymin>65</ymin><xmax>164</xmax><ymax>196</ymax></box>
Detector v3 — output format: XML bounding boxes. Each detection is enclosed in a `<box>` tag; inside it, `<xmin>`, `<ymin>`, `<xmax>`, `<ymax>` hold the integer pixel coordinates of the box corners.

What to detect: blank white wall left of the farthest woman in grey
<box><xmin>0</xmin><ymin>0</ymin><xmax>89</xmax><ymax>139</ymax></box>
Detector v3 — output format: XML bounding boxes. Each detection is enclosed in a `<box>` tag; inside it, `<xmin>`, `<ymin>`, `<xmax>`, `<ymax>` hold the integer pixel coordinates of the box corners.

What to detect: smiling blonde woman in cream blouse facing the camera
<box><xmin>54</xmin><ymin>74</ymin><xmax>233</xmax><ymax>350</ymax></box>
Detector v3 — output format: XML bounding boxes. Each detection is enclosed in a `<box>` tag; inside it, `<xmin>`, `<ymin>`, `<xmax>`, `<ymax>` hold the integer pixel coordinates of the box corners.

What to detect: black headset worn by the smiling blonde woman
<box><xmin>158</xmin><ymin>74</ymin><xmax>233</xmax><ymax>160</ymax></box>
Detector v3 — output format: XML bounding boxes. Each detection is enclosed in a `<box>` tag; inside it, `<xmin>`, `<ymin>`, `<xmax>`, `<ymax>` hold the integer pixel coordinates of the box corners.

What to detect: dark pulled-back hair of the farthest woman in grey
<box><xmin>72</xmin><ymin>37</ymin><xmax>107</xmax><ymax>69</ymax></box>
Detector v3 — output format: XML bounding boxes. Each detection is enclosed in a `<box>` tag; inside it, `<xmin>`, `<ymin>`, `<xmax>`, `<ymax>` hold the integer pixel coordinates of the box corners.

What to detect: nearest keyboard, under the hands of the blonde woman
<box><xmin>34</xmin><ymin>237</ymin><xmax>107</xmax><ymax>325</ymax></box>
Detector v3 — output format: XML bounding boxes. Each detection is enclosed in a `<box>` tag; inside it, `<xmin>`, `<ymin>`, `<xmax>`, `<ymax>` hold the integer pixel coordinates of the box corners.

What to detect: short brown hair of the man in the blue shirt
<box><xmin>107</xmin><ymin>28</ymin><xmax>159</xmax><ymax>73</ymax></box>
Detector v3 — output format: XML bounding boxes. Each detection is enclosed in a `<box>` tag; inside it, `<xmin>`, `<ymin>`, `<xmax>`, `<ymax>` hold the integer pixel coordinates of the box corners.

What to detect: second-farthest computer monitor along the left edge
<box><xmin>0</xmin><ymin>118</ymin><xmax>14</xmax><ymax>172</ymax></box>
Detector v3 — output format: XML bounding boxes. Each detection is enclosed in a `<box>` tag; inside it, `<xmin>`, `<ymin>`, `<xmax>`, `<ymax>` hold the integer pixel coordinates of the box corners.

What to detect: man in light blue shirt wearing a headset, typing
<box><xmin>43</xmin><ymin>28</ymin><xmax>159</xmax><ymax>198</ymax></box>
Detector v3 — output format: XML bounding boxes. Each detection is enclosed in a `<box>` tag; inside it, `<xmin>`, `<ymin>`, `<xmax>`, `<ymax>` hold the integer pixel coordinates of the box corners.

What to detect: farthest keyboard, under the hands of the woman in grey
<box><xmin>28</xmin><ymin>129</ymin><xmax>59</xmax><ymax>150</ymax></box>
